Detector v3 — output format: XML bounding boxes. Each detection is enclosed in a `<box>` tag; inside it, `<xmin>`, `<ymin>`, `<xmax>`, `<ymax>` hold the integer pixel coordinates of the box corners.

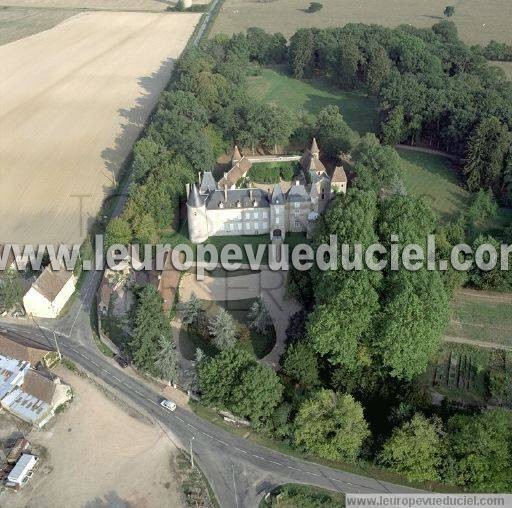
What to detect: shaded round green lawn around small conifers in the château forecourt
<box><xmin>180</xmin><ymin>298</ymin><xmax>276</xmax><ymax>360</ymax></box>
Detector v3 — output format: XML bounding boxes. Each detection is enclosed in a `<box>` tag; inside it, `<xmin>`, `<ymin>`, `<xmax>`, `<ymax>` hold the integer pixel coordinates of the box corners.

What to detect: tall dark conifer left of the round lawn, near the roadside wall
<box><xmin>129</xmin><ymin>284</ymin><xmax>172</xmax><ymax>375</ymax></box>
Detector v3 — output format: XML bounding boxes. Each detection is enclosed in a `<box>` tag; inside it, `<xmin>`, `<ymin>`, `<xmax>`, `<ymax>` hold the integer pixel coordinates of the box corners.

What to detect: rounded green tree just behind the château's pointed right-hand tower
<box><xmin>315</xmin><ymin>104</ymin><xmax>357</xmax><ymax>158</ymax></box>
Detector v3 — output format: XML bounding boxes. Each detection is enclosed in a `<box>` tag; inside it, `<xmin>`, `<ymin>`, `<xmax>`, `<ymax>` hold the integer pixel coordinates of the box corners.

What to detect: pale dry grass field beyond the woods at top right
<box><xmin>212</xmin><ymin>0</ymin><xmax>512</xmax><ymax>44</ymax></box>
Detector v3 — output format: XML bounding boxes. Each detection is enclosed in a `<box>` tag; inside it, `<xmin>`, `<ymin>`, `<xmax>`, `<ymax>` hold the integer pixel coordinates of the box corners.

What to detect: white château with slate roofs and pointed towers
<box><xmin>187</xmin><ymin>139</ymin><xmax>347</xmax><ymax>243</ymax></box>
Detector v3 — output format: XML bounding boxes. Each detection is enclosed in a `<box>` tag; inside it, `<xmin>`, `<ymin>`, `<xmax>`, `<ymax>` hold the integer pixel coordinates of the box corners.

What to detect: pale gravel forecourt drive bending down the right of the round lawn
<box><xmin>180</xmin><ymin>267</ymin><xmax>300</xmax><ymax>368</ymax></box>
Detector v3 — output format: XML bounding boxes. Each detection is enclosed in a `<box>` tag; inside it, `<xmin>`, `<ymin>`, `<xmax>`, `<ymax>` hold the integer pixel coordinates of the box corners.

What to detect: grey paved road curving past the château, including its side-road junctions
<box><xmin>0</xmin><ymin>272</ymin><xmax>422</xmax><ymax>508</ymax></box>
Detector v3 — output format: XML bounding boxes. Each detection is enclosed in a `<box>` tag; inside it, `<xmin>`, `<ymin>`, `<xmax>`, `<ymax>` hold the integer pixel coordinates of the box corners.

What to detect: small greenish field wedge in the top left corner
<box><xmin>0</xmin><ymin>7</ymin><xmax>78</xmax><ymax>45</ymax></box>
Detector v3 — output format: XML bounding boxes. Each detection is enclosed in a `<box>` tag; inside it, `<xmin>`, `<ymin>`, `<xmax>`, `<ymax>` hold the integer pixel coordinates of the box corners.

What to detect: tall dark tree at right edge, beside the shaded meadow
<box><xmin>464</xmin><ymin>116</ymin><xmax>510</xmax><ymax>192</ymax></box>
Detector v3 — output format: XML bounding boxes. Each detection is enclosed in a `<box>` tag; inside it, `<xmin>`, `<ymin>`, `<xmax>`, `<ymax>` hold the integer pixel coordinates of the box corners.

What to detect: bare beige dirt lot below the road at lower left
<box><xmin>0</xmin><ymin>369</ymin><xmax>184</xmax><ymax>508</ymax></box>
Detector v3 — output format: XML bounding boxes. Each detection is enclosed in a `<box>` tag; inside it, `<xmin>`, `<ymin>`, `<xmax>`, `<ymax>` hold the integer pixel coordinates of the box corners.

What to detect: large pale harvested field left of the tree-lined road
<box><xmin>0</xmin><ymin>12</ymin><xmax>200</xmax><ymax>244</ymax></box>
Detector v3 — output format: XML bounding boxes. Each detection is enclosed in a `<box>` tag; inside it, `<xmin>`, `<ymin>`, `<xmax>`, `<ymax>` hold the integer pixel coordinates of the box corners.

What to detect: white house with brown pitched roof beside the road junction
<box><xmin>23</xmin><ymin>265</ymin><xmax>76</xmax><ymax>318</ymax></box>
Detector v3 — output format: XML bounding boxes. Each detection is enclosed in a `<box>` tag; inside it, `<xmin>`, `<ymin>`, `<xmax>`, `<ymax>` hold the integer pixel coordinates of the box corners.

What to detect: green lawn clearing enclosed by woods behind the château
<box><xmin>249</xmin><ymin>67</ymin><xmax>379</xmax><ymax>134</ymax></box>
